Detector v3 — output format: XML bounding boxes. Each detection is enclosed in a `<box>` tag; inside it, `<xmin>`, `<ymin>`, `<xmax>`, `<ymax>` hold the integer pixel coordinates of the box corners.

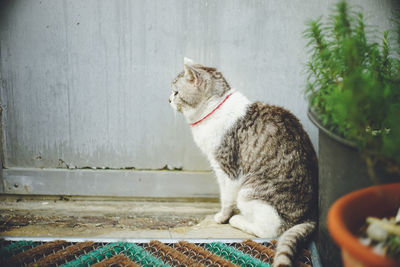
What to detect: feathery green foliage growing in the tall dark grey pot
<box><xmin>304</xmin><ymin>1</ymin><xmax>400</xmax><ymax>178</ymax></box>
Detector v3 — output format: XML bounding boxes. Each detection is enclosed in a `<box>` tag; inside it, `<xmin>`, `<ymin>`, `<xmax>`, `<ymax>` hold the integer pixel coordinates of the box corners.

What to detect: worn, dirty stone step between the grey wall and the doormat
<box><xmin>0</xmin><ymin>195</ymin><xmax>253</xmax><ymax>239</ymax></box>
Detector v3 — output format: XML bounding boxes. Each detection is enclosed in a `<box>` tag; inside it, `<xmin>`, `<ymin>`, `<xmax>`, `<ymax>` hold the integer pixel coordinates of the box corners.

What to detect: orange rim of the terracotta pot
<box><xmin>328</xmin><ymin>183</ymin><xmax>400</xmax><ymax>266</ymax></box>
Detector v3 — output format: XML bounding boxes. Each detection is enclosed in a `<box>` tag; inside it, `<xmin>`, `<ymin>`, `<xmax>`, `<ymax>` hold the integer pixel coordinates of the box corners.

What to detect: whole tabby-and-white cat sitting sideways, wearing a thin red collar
<box><xmin>169</xmin><ymin>58</ymin><xmax>318</xmax><ymax>266</ymax></box>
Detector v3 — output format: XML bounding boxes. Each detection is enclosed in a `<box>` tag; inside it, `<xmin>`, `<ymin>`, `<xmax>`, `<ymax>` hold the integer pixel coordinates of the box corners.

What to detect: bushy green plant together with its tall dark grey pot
<box><xmin>304</xmin><ymin>1</ymin><xmax>400</xmax><ymax>266</ymax></box>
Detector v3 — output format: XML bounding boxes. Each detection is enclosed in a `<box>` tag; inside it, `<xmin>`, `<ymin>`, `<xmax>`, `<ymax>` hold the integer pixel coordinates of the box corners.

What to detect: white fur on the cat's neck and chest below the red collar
<box><xmin>191</xmin><ymin>91</ymin><xmax>250</xmax><ymax>160</ymax></box>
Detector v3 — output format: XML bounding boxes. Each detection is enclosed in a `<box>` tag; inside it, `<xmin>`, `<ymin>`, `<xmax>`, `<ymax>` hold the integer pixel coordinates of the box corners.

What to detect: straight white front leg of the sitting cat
<box><xmin>214</xmin><ymin>171</ymin><xmax>239</xmax><ymax>223</ymax></box>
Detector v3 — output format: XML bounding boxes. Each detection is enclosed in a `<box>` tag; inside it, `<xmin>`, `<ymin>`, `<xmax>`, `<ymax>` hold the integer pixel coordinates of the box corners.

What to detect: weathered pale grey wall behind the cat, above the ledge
<box><xmin>0</xmin><ymin>0</ymin><xmax>395</xmax><ymax>170</ymax></box>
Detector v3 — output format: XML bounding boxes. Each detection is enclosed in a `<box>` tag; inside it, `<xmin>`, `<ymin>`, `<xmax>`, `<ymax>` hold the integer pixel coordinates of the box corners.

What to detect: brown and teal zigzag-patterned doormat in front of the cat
<box><xmin>0</xmin><ymin>240</ymin><xmax>319</xmax><ymax>267</ymax></box>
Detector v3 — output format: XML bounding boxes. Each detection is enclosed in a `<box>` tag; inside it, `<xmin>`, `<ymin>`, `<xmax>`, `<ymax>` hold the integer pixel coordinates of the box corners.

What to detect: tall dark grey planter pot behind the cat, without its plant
<box><xmin>308</xmin><ymin>109</ymin><xmax>393</xmax><ymax>266</ymax></box>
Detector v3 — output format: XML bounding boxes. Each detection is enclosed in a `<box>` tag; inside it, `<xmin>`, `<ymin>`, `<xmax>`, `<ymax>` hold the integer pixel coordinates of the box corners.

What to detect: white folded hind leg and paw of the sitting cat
<box><xmin>229</xmin><ymin>189</ymin><xmax>282</xmax><ymax>238</ymax></box>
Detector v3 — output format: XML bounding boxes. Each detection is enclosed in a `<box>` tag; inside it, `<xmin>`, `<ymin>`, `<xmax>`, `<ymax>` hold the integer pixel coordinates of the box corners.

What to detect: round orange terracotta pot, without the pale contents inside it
<box><xmin>328</xmin><ymin>183</ymin><xmax>400</xmax><ymax>267</ymax></box>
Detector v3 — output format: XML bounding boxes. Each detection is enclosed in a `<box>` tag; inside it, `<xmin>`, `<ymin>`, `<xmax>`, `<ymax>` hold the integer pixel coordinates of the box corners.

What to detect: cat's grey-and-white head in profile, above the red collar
<box><xmin>169</xmin><ymin>58</ymin><xmax>230</xmax><ymax>116</ymax></box>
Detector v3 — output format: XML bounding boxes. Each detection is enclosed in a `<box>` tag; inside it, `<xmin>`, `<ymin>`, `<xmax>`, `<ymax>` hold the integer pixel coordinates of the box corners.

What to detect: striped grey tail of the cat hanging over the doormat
<box><xmin>272</xmin><ymin>222</ymin><xmax>316</xmax><ymax>267</ymax></box>
